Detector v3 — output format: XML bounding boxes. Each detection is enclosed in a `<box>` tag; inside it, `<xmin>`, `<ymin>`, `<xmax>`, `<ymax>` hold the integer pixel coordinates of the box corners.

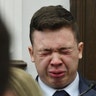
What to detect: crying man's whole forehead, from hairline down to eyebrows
<box><xmin>33</xmin><ymin>28</ymin><xmax>76</xmax><ymax>46</ymax></box>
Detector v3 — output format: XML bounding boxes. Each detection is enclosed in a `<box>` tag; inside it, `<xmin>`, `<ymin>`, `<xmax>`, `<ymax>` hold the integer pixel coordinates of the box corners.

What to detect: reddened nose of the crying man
<box><xmin>50</xmin><ymin>53</ymin><xmax>62</xmax><ymax>67</ymax></box>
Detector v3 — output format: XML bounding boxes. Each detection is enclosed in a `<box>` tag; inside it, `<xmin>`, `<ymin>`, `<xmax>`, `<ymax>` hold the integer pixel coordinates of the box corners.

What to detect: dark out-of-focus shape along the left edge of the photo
<box><xmin>0</xmin><ymin>16</ymin><xmax>10</xmax><ymax>96</ymax></box>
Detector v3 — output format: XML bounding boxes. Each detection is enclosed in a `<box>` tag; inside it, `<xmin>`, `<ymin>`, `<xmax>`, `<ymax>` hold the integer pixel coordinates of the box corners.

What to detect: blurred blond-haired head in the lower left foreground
<box><xmin>3</xmin><ymin>67</ymin><xmax>42</xmax><ymax>96</ymax></box>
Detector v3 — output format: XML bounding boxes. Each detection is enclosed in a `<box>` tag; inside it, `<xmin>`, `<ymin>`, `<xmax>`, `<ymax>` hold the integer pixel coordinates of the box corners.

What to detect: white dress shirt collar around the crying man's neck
<box><xmin>38</xmin><ymin>73</ymin><xmax>79</xmax><ymax>96</ymax></box>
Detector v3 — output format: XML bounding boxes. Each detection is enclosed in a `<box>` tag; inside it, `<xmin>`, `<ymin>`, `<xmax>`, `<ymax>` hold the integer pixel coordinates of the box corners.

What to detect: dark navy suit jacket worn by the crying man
<box><xmin>36</xmin><ymin>75</ymin><xmax>96</xmax><ymax>96</ymax></box>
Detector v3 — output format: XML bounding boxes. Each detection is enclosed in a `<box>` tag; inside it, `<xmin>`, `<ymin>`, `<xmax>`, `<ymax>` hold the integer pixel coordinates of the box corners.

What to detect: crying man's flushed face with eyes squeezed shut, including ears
<box><xmin>29</xmin><ymin>28</ymin><xmax>83</xmax><ymax>88</ymax></box>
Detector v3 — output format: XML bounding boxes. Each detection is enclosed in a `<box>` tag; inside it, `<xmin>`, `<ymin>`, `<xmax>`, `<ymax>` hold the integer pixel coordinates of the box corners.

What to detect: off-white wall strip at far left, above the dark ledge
<box><xmin>0</xmin><ymin>0</ymin><xmax>23</xmax><ymax>60</ymax></box>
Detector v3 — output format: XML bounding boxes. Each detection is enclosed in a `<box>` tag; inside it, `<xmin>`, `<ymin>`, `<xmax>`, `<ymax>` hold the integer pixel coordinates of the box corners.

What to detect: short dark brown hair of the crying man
<box><xmin>30</xmin><ymin>5</ymin><xmax>80</xmax><ymax>44</ymax></box>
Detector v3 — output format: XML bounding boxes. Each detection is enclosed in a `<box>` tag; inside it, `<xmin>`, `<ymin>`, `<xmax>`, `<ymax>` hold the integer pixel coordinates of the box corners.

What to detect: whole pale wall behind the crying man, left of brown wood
<box><xmin>0</xmin><ymin>0</ymin><xmax>70</xmax><ymax>78</ymax></box>
